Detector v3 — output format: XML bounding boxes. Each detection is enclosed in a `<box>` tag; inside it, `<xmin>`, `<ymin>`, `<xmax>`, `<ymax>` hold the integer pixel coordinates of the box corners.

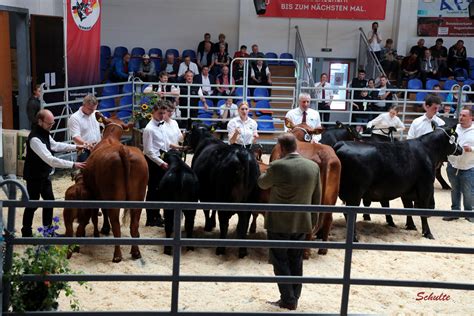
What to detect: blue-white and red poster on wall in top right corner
<box><xmin>417</xmin><ymin>0</ymin><xmax>474</xmax><ymax>37</ymax></box>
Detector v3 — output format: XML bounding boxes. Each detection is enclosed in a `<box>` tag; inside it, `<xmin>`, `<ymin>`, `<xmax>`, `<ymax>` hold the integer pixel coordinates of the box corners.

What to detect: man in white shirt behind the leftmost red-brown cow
<box><xmin>67</xmin><ymin>94</ymin><xmax>101</xmax><ymax>161</ymax></box>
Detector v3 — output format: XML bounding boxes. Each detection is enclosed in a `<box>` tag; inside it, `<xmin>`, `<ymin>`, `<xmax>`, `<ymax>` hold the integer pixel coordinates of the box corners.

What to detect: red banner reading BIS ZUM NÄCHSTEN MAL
<box><xmin>261</xmin><ymin>0</ymin><xmax>387</xmax><ymax>20</ymax></box>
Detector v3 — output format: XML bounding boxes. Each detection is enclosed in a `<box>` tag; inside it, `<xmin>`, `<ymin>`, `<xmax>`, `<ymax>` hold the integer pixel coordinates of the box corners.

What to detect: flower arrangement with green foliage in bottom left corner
<box><xmin>7</xmin><ymin>216</ymin><xmax>85</xmax><ymax>312</ymax></box>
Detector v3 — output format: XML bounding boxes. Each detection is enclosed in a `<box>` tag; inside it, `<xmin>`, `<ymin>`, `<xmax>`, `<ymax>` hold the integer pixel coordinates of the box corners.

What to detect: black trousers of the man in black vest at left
<box><xmin>21</xmin><ymin>178</ymin><xmax>54</xmax><ymax>237</ymax></box>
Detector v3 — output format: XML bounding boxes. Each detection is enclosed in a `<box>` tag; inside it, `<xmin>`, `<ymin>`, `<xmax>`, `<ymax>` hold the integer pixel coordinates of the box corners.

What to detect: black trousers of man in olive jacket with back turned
<box><xmin>267</xmin><ymin>231</ymin><xmax>306</xmax><ymax>304</ymax></box>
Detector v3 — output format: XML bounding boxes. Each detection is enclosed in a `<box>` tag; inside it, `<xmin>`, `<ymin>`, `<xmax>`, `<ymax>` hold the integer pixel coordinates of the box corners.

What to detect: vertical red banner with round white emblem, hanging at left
<box><xmin>66</xmin><ymin>0</ymin><xmax>100</xmax><ymax>86</ymax></box>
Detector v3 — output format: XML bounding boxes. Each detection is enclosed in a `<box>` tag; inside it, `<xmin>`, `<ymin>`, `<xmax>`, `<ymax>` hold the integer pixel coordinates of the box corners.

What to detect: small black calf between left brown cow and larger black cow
<box><xmin>158</xmin><ymin>150</ymin><xmax>199</xmax><ymax>255</ymax></box>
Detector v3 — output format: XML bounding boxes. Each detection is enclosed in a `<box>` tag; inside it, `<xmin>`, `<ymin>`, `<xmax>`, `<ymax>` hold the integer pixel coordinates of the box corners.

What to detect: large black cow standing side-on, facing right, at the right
<box><xmin>334</xmin><ymin>128</ymin><xmax>462</xmax><ymax>241</ymax></box>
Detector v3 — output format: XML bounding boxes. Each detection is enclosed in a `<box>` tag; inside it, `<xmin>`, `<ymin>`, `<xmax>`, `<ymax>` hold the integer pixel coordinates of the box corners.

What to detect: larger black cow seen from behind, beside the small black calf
<box><xmin>185</xmin><ymin>125</ymin><xmax>260</xmax><ymax>258</ymax></box>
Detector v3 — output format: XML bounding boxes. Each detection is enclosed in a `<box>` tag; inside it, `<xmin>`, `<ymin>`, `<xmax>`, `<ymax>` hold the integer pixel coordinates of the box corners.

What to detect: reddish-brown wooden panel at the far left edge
<box><xmin>0</xmin><ymin>11</ymin><xmax>13</xmax><ymax>129</ymax></box>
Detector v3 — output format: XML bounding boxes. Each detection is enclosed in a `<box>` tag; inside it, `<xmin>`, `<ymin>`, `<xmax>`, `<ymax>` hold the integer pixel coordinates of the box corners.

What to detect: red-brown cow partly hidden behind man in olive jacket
<box><xmin>270</xmin><ymin>119</ymin><xmax>341</xmax><ymax>258</ymax></box>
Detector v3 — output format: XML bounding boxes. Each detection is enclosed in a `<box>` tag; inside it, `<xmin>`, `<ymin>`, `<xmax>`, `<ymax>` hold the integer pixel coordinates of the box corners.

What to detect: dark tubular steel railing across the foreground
<box><xmin>0</xmin><ymin>180</ymin><xmax>474</xmax><ymax>315</ymax></box>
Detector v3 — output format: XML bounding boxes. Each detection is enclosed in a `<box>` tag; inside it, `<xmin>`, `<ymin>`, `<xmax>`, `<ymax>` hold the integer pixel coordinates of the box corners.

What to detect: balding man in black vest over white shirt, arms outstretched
<box><xmin>21</xmin><ymin>110</ymin><xmax>86</xmax><ymax>237</ymax></box>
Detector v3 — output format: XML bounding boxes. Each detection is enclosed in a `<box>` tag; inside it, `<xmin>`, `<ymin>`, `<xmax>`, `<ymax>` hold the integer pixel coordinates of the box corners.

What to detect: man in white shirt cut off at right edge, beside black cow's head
<box><xmin>443</xmin><ymin>106</ymin><xmax>474</xmax><ymax>223</ymax></box>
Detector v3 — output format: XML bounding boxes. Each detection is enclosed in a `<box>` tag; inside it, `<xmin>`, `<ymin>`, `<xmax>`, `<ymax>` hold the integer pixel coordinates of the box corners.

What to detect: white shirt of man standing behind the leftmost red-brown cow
<box><xmin>67</xmin><ymin>106</ymin><xmax>101</xmax><ymax>144</ymax></box>
